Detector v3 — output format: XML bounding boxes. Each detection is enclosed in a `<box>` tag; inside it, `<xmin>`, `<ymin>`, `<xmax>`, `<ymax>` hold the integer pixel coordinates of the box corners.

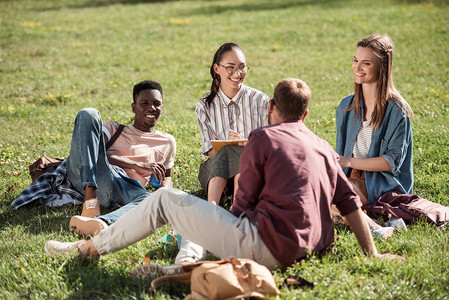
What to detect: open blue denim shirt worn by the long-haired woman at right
<box><xmin>336</xmin><ymin>95</ymin><xmax>413</xmax><ymax>203</ymax></box>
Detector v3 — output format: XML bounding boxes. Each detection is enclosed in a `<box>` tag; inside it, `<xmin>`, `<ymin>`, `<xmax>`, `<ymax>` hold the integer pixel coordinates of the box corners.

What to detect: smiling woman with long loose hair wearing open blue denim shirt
<box><xmin>336</xmin><ymin>34</ymin><xmax>413</xmax><ymax>237</ymax></box>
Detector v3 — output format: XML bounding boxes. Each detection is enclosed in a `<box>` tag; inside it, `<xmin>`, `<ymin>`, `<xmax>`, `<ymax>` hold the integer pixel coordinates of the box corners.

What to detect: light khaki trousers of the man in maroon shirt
<box><xmin>93</xmin><ymin>188</ymin><xmax>281</xmax><ymax>269</ymax></box>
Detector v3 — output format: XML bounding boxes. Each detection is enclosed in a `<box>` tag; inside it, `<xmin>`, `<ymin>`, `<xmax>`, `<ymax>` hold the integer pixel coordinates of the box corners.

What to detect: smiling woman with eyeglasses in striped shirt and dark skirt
<box><xmin>196</xmin><ymin>43</ymin><xmax>269</xmax><ymax>204</ymax></box>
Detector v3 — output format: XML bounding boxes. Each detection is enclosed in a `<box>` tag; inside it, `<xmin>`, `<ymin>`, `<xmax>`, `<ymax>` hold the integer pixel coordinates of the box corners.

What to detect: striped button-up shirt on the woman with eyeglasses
<box><xmin>196</xmin><ymin>85</ymin><xmax>269</xmax><ymax>154</ymax></box>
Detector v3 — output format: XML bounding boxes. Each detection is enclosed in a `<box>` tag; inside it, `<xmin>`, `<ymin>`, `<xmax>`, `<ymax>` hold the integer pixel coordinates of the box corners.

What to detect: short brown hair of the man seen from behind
<box><xmin>273</xmin><ymin>78</ymin><xmax>312</xmax><ymax>121</ymax></box>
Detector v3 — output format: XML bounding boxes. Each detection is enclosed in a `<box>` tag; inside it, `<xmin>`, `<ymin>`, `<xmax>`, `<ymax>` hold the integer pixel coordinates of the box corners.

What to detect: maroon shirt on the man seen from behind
<box><xmin>231</xmin><ymin>121</ymin><xmax>361</xmax><ymax>266</ymax></box>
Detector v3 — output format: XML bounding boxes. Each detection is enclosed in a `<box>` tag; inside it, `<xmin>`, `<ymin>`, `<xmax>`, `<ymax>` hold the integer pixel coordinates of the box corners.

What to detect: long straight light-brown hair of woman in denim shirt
<box><xmin>347</xmin><ymin>33</ymin><xmax>413</xmax><ymax>129</ymax></box>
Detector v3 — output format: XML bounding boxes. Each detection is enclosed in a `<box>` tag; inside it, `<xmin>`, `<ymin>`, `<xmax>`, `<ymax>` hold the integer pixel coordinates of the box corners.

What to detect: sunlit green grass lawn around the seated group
<box><xmin>0</xmin><ymin>0</ymin><xmax>449</xmax><ymax>299</ymax></box>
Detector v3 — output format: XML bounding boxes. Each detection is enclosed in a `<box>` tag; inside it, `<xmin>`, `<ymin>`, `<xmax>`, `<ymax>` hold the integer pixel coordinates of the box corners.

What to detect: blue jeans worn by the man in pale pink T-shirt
<box><xmin>67</xmin><ymin>108</ymin><xmax>150</xmax><ymax>223</ymax></box>
